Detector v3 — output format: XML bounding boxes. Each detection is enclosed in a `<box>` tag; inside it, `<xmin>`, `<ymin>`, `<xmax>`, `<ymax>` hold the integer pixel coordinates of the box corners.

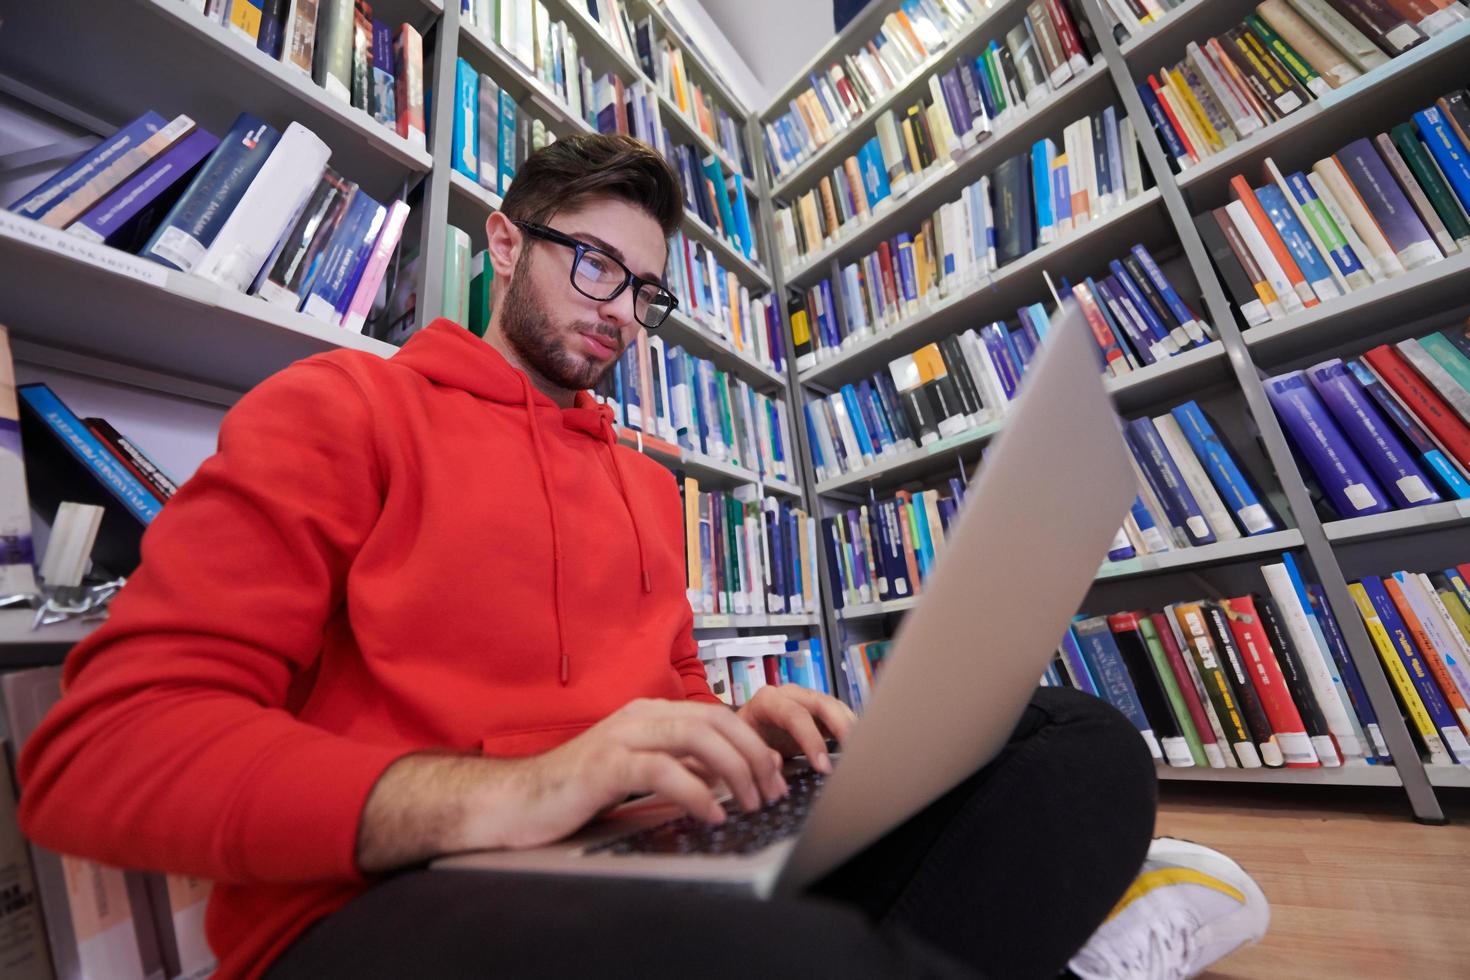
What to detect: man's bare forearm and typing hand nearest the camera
<box><xmin>357</xmin><ymin>696</ymin><xmax>793</xmax><ymax>873</ymax></box>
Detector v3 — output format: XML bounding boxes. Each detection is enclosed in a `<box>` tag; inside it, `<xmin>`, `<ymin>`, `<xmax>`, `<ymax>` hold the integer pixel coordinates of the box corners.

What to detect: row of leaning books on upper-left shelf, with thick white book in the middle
<box><xmin>9</xmin><ymin>112</ymin><xmax>409</xmax><ymax>337</ymax></box>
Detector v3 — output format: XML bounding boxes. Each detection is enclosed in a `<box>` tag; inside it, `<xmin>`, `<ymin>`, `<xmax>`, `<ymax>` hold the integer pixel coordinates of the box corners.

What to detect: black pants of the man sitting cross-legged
<box><xmin>266</xmin><ymin>688</ymin><xmax>1155</xmax><ymax>980</ymax></box>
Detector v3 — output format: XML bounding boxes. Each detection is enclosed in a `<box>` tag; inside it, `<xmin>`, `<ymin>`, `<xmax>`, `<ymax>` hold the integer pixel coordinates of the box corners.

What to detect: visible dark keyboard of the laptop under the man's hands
<box><xmin>585</xmin><ymin>768</ymin><xmax>823</xmax><ymax>854</ymax></box>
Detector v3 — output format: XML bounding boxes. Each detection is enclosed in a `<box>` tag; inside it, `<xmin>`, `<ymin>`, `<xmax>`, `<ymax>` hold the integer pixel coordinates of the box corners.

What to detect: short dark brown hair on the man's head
<box><xmin>500</xmin><ymin>134</ymin><xmax>684</xmax><ymax>238</ymax></box>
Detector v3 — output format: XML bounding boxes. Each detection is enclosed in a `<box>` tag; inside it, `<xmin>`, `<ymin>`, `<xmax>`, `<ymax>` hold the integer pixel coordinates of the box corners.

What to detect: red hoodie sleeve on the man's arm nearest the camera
<box><xmin>19</xmin><ymin>360</ymin><xmax>403</xmax><ymax>882</ymax></box>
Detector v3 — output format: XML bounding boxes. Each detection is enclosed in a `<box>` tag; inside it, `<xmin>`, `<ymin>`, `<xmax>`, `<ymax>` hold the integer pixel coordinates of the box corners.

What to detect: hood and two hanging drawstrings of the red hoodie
<box><xmin>392</xmin><ymin>317</ymin><xmax>653</xmax><ymax>685</ymax></box>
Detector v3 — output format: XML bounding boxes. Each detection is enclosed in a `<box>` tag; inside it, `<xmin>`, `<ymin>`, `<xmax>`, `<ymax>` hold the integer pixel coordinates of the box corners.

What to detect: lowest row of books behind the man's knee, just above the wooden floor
<box><xmin>1045</xmin><ymin>555</ymin><xmax>1470</xmax><ymax>768</ymax></box>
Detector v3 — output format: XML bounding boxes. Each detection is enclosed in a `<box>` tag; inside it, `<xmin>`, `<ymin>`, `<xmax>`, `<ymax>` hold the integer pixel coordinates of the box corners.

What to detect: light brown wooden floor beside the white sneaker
<box><xmin>1158</xmin><ymin>785</ymin><xmax>1470</xmax><ymax>980</ymax></box>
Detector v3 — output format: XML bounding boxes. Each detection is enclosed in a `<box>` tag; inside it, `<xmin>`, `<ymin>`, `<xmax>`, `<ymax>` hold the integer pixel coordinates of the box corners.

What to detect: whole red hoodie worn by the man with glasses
<box><xmin>19</xmin><ymin>320</ymin><xmax>714</xmax><ymax>979</ymax></box>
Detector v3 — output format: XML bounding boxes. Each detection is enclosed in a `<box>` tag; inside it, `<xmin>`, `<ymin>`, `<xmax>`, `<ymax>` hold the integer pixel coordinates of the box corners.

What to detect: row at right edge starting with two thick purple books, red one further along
<box><xmin>1266</xmin><ymin>339</ymin><xmax>1470</xmax><ymax>519</ymax></box>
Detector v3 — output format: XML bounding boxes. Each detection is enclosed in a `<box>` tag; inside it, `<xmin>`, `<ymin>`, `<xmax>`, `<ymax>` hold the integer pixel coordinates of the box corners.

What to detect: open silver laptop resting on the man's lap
<box><xmin>434</xmin><ymin>304</ymin><xmax>1136</xmax><ymax>898</ymax></box>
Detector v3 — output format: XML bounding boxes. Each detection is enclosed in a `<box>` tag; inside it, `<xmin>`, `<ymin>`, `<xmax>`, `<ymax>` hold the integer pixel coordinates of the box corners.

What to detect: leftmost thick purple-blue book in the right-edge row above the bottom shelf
<box><xmin>1266</xmin><ymin>370</ymin><xmax>1392</xmax><ymax>517</ymax></box>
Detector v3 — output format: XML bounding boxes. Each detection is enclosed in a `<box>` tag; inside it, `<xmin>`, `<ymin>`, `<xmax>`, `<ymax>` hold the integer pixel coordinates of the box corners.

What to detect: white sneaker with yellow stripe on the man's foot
<box><xmin>1067</xmin><ymin>837</ymin><xmax>1272</xmax><ymax>980</ymax></box>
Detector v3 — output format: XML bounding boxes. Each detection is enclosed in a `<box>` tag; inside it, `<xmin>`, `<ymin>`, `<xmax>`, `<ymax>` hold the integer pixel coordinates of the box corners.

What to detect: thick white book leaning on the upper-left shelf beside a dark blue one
<box><xmin>194</xmin><ymin>122</ymin><xmax>332</xmax><ymax>292</ymax></box>
